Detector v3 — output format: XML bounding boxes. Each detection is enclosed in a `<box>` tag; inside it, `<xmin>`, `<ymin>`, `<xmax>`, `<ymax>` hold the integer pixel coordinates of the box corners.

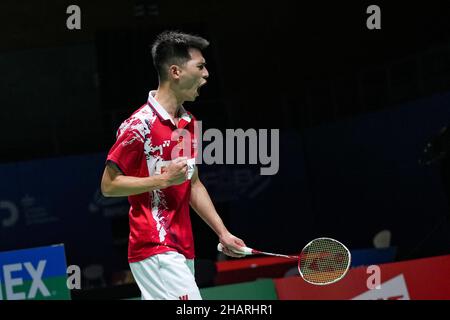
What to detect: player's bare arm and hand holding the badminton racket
<box><xmin>190</xmin><ymin>167</ymin><xmax>245</xmax><ymax>257</ymax></box>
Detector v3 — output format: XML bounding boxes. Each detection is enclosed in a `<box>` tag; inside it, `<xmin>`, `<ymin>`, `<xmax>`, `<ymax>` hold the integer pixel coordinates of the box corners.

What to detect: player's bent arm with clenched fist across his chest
<box><xmin>101</xmin><ymin>158</ymin><xmax>187</xmax><ymax>197</ymax></box>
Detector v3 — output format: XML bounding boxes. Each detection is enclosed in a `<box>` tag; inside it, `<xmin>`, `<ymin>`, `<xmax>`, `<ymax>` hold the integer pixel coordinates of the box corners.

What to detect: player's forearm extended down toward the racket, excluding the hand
<box><xmin>190</xmin><ymin>181</ymin><xmax>228</xmax><ymax>237</ymax></box>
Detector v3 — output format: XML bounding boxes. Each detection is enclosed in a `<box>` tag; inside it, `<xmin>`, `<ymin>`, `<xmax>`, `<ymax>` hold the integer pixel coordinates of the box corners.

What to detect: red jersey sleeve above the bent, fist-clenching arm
<box><xmin>107</xmin><ymin>129</ymin><xmax>144</xmax><ymax>176</ymax></box>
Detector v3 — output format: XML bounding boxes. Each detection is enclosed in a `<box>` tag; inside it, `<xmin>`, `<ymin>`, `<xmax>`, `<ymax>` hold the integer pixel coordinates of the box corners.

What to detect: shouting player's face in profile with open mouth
<box><xmin>178</xmin><ymin>49</ymin><xmax>209</xmax><ymax>101</ymax></box>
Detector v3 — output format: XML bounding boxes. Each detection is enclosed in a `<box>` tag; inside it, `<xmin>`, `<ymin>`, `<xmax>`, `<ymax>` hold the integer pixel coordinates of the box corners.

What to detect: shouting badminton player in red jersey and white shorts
<box><xmin>101</xmin><ymin>31</ymin><xmax>245</xmax><ymax>300</ymax></box>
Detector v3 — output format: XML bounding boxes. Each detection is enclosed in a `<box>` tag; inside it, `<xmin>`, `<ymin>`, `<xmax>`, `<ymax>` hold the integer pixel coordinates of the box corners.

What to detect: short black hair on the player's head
<box><xmin>152</xmin><ymin>31</ymin><xmax>209</xmax><ymax>80</ymax></box>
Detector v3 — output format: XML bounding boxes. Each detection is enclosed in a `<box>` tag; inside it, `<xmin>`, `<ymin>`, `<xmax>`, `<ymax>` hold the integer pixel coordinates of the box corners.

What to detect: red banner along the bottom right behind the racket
<box><xmin>274</xmin><ymin>255</ymin><xmax>450</xmax><ymax>300</ymax></box>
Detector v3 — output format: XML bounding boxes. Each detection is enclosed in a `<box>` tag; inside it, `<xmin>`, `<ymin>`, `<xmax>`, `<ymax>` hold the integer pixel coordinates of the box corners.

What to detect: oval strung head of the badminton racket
<box><xmin>298</xmin><ymin>237</ymin><xmax>351</xmax><ymax>285</ymax></box>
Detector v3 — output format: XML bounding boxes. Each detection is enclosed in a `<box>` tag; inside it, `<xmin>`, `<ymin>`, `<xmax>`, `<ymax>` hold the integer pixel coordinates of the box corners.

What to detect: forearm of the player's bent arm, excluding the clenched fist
<box><xmin>101</xmin><ymin>175</ymin><xmax>168</xmax><ymax>197</ymax></box>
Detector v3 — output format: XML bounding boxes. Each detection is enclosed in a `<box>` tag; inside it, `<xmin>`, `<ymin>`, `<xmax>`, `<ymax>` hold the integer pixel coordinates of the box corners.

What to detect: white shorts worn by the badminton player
<box><xmin>130</xmin><ymin>251</ymin><xmax>202</xmax><ymax>300</ymax></box>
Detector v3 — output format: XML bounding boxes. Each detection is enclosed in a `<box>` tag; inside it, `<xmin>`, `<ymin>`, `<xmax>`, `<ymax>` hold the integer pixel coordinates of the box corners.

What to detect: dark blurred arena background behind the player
<box><xmin>0</xmin><ymin>0</ymin><xmax>450</xmax><ymax>295</ymax></box>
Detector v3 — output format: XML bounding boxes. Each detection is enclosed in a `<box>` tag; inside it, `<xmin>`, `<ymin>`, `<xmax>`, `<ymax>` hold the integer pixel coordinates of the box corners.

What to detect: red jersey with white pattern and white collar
<box><xmin>107</xmin><ymin>91</ymin><xmax>196</xmax><ymax>262</ymax></box>
